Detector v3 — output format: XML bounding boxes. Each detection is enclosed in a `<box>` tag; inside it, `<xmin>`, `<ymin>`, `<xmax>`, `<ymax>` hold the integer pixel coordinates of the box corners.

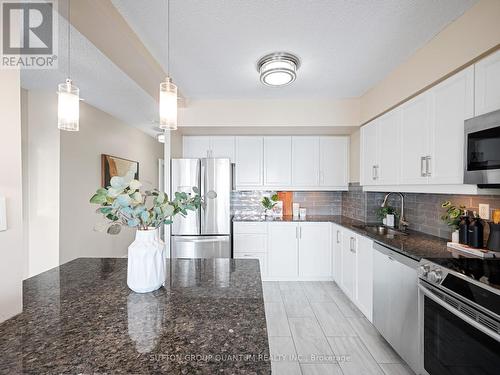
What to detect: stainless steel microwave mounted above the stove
<box><xmin>464</xmin><ymin>110</ymin><xmax>500</xmax><ymax>188</ymax></box>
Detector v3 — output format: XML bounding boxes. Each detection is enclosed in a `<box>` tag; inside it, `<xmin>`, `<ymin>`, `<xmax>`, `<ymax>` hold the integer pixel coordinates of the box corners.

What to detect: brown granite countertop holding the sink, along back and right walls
<box><xmin>233</xmin><ymin>215</ymin><xmax>453</xmax><ymax>261</ymax></box>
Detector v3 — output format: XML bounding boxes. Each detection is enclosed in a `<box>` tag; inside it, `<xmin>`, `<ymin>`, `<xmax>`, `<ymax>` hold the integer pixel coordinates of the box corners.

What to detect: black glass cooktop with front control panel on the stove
<box><xmin>431</xmin><ymin>258</ymin><xmax>500</xmax><ymax>315</ymax></box>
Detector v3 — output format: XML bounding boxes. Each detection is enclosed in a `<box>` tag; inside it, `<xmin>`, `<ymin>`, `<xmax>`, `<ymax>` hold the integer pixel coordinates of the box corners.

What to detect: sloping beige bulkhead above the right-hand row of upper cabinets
<box><xmin>360</xmin><ymin>0</ymin><xmax>500</xmax><ymax>123</ymax></box>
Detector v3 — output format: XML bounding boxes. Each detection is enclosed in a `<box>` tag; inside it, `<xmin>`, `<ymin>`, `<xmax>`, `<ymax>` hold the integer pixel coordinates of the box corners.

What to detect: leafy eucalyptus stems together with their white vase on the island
<box><xmin>90</xmin><ymin>173</ymin><xmax>216</xmax><ymax>293</ymax></box>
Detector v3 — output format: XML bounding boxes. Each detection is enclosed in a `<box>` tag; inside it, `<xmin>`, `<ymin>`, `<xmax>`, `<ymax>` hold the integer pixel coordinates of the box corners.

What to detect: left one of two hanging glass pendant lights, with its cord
<box><xmin>57</xmin><ymin>0</ymin><xmax>80</xmax><ymax>131</ymax></box>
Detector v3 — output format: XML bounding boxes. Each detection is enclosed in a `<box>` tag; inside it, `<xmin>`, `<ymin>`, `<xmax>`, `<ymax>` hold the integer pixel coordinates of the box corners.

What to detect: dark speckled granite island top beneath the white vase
<box><xmin>0</xmin><ymin>258</ymin><xmax>271</xmax><ymax>374</ymax></box>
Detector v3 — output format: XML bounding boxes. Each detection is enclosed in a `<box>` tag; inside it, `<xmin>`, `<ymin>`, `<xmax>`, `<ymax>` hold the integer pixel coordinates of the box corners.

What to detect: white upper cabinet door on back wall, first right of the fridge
<box><xmin>236</xmin><ymin>136</ymin><xmax>264</xmax><ymax>190</ymax></box>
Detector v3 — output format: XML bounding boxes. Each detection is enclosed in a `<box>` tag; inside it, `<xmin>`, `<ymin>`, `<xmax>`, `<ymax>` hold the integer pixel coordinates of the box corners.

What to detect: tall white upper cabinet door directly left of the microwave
<box><xmin>426</xmin><ymin>64</ymin><xmax>474</xmax><ymax>184</ymax></box>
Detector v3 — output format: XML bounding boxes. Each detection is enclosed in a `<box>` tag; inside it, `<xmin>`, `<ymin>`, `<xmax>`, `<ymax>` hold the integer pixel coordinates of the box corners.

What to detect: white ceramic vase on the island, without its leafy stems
<box><xmin>127</xmin><ymin>229</ymin><xmax>165</xmax><ymax>293</ymax></box>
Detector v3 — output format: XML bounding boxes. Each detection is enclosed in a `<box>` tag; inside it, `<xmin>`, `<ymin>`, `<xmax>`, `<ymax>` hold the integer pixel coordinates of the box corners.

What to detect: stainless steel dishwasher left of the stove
<box><xmin>373</xmin><ymin>243</ymin><xmax>419</xmax><ymax>373</ymax></box>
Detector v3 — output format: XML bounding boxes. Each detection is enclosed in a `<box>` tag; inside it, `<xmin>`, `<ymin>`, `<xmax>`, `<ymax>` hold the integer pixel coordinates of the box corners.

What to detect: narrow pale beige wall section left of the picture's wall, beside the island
<box><xmin>21</xmin><ymin>90</ymin><xmax>60</xmax><ymax>278</ymax></box>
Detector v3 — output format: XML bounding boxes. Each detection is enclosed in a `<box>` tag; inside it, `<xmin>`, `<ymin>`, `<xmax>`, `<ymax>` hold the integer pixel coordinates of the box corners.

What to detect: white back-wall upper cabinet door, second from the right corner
<box><xmin>292</xmin><ymin>137</ymin><xmax>319</xmax><ymax>188</ymax></box>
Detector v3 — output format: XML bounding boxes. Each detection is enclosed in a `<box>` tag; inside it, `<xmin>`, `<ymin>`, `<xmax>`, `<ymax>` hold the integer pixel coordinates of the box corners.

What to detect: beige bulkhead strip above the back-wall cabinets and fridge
<box><xmin>179</xmin><ymin>99</ymin><xmax>360</xmax><ymax>127</ymax></box>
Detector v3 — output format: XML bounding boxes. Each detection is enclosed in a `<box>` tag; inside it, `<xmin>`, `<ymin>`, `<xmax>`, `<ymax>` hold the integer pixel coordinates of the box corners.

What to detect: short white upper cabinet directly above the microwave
<box><xmin>474</xmin><ymin>51</ymin><xmax>500</xmax><ymax>116</ymax></box>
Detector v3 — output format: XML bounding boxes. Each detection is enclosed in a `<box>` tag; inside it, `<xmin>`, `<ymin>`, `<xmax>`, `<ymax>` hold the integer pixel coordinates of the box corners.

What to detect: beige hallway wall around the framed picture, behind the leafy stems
<box><xmin>60</xmin><ymin>103</ymin><xmax>163</xmax><ymax>264</ymax></box>
